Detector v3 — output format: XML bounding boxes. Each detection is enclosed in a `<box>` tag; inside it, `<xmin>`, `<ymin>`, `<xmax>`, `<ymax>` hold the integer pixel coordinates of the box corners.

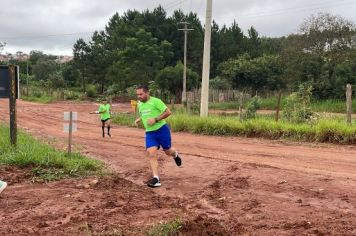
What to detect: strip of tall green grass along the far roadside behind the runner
<box><xmin>114</xmin><ymin>113</ymin><xmax>356</xmax><ymax>144</ymax></box>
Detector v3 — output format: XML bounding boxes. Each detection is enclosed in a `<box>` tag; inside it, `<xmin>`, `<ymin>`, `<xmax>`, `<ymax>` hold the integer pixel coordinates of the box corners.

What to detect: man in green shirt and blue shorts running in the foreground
<box><xmin>135</xmin><ymin>86</ymin><xmax>182</xmax><ymax>188</ymax></box>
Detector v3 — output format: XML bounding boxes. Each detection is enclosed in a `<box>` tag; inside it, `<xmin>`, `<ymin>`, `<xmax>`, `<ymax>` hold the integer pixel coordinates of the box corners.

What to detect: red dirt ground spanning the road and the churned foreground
<box><xmin>0</xmin><ymin>100</ymin><xmax>356</xmax><ymax>235</ymax></box>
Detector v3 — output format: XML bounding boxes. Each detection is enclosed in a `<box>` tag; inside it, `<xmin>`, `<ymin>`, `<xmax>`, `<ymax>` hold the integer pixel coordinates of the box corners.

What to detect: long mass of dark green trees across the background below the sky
<box><xmin>0</xmin><ymin>6</ymin><xmax>356</xmax><ymax>99</ymax></box>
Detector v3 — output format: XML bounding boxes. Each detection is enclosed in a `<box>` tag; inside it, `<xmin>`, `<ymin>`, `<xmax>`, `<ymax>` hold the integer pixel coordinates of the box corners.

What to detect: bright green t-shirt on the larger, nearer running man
<box><xmin>138</xmin><ymin>97</ymin><xmax>167</xmax><ymax>132</ymax></box>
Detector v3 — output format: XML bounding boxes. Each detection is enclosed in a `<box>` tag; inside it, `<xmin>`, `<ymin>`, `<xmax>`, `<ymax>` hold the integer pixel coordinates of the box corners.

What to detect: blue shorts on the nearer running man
<box><xmin>146</xmin><ymin>124</ymin><xmax>172</xmax><ymax>150</ymax></box>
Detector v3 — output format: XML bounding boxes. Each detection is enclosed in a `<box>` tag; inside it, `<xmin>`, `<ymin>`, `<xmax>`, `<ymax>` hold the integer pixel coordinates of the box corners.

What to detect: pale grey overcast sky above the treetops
<box><xmin>0</xmin><ymin>0</ymin><xmax>356</xmax><ymax>55</ymax></box>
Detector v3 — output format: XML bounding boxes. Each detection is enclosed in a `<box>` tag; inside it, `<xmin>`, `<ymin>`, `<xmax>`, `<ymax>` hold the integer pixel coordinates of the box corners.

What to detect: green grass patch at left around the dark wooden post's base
<box><xmin>0</xmin><ymin>124</ymin><xmax>104</xmax><ymax>181</ymax></box>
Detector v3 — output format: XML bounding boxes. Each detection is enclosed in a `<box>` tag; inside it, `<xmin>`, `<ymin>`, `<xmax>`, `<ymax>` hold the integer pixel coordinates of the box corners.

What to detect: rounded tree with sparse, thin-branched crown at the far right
<box><xmin>282</xmin><ymin>13</ymin><xmax>356</xmax><ymax>99</ymax></box>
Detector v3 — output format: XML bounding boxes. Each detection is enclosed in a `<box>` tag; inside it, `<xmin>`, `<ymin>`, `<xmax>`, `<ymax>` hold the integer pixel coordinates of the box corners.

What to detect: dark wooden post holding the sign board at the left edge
<box><xmin>9</xmin><ymin>65</ymin><xmax>17</xmax><ymax>145</ymax></box>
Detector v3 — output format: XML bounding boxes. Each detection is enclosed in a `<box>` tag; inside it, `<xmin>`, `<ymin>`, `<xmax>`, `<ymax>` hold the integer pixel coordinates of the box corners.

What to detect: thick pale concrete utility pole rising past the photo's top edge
<box><xmin>200</xmin><ymin>0</ymin><xmax>212</xmax><ymax>117</ymax></box>
